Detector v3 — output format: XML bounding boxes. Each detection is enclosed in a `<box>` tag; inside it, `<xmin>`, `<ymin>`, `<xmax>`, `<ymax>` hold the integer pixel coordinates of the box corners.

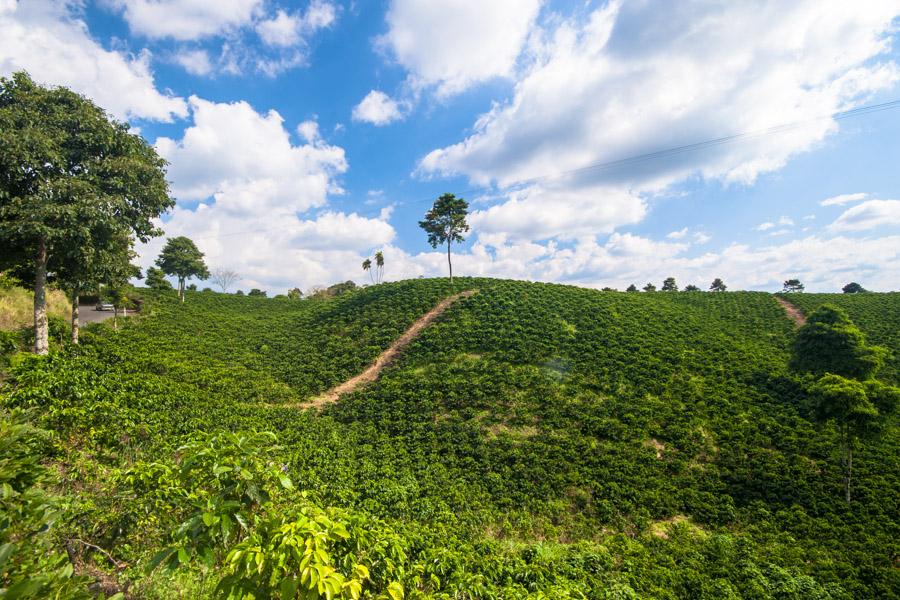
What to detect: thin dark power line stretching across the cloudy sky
<box><xmin>185</xmin><ymin>99</ymin><xmax>900</xmax><ymax>240</ymax></box>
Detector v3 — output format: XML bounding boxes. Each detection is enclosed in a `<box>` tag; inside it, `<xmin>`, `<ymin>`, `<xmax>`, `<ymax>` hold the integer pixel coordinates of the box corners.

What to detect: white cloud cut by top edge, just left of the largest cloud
<box><xmin>379</xmin><ymin>0</ymin><xmax>541</xmax><ymax>96</ymax></box>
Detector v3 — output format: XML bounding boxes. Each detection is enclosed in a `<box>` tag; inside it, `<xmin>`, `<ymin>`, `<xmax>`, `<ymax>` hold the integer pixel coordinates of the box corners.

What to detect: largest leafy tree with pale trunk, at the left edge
<box><xmin>0</xmin><ymin>72</ymin><xmax>174</xmax><ymax>354</ymax></box>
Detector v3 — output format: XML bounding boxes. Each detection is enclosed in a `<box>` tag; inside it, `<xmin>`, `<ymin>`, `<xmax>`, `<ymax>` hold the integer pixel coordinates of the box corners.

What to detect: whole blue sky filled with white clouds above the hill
<box><xmin>0</xmin><ymin>0</ymin><xmax>900</xmax><ymax>294</ymax></box>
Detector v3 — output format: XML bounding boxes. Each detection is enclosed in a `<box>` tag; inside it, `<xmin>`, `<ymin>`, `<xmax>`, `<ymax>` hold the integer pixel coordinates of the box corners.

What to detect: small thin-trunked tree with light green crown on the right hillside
<box><xmin>812</xmin><ymin>373</ymin><xmax>900</xmax><ymax>504</ymax></box>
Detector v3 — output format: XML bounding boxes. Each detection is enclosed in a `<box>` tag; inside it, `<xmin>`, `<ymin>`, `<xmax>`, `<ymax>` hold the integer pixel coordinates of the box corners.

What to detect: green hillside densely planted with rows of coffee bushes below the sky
<box><xmin>2</xmin><ymin>278</ymin><xmax>900</xmax><ymax>598</ymax></box>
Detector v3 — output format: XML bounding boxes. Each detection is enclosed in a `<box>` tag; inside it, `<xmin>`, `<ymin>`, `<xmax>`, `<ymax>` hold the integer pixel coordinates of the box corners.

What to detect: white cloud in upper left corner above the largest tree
<box><xmin>0</xmin><ymin>0</ymin><xmax>187</xmax><ymax>121</ymax></box>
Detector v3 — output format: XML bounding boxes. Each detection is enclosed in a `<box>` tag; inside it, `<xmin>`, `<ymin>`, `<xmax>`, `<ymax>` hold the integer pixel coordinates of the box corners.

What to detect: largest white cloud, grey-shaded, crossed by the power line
<box><xmin>417</xmin><ymin>0</ymin><xmax>900</xmax><ymax>247</ymax></box>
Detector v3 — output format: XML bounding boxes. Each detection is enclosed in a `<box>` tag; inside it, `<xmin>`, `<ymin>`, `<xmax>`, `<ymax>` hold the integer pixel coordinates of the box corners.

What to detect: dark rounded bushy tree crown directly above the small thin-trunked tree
<box><xmin>791</xmin><ymin>304</ymin><xmax>887</xmax><ymax>379</ymax></box>
